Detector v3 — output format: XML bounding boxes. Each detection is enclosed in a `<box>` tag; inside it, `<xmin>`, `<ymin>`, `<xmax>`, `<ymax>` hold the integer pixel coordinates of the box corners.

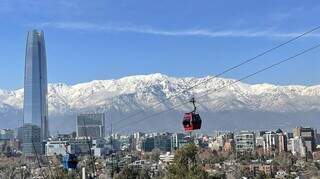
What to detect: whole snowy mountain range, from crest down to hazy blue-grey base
<box><xmin>0</xmin><ymin>73</ymin><xmax>320</xmax><ymax>133</ymax></box>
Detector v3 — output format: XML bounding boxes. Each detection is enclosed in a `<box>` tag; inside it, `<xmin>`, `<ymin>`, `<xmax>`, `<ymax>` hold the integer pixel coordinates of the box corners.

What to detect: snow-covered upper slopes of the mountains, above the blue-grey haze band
<box><xmin>0</xmin><ymin>74</ymin><xmax>320</xmax><ymax>133</ymax></box>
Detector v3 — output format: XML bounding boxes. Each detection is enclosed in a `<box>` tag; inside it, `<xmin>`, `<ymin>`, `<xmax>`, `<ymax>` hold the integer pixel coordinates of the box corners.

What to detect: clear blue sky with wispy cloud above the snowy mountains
<box><xmin>0</xmin><ymin>0</ymin><xmax>320</xmax><ymax>89</ymax></box>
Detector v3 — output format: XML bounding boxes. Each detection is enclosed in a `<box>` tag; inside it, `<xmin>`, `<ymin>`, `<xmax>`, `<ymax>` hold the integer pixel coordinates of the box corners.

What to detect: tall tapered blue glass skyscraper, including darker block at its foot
<box><xmin>22</xmin><ymin>30</ymin><xmax>49</xmax><ymax>154</ymax></box>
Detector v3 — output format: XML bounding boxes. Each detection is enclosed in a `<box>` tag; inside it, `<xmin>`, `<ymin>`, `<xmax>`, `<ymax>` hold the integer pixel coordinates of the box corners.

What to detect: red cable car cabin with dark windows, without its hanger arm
<box><xmin>182</xmin><ymin>112</ymin><xmax>202</xmax><ymax>132</ymax></box>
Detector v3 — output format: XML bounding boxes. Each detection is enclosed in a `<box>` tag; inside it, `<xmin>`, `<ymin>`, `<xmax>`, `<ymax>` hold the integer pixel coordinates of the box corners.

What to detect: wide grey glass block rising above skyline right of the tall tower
<box><xmin>77</xmin><ymin>113</ymin><xmax>105</xmax><ymax>138</ymax></box>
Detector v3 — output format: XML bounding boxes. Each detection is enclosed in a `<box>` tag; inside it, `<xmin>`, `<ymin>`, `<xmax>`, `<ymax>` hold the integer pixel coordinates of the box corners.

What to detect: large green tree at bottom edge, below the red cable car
<box><xmin>168</xmin><ymin>143</ymin><xmax>209</xmax><ymax>179</ymax></box>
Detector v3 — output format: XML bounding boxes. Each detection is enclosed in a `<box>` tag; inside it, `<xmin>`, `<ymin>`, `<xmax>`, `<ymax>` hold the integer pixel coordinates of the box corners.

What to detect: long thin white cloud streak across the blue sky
<box><xmin>37</xmin><ymin>22</ymin><xmax>320</xmax><ymax>37</ymax></box>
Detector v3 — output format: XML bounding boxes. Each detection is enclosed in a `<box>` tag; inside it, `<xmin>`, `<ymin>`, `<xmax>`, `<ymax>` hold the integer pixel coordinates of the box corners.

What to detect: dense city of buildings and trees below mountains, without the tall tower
<box><xmin>0</xmin><ymin>114</ymin><xmax>320</xmax><ymax>178</ymax></box>
